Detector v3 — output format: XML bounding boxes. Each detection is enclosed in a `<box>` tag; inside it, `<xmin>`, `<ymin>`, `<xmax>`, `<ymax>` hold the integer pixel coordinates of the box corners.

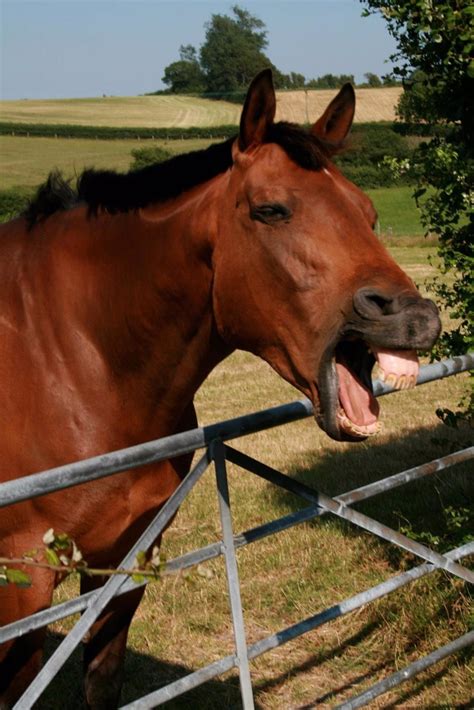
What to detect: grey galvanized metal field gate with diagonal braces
<box><xmin>0</xmin><ymin>354</ymin><xmax>474</xmax><ymax>710</ymax></box>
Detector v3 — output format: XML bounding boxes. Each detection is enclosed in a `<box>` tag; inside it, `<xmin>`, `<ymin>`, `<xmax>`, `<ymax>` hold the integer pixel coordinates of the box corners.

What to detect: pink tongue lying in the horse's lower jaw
<box><xmin>336</xmin><ymin>358</ymin><xmax>380</xmax><ymax>437</ymax></box>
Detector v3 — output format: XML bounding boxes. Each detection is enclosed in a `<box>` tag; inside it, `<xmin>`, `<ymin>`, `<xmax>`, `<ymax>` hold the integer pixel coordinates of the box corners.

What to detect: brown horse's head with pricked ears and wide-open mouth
<box><xmin>213</xmin><ymin>70</ymin><xmax>440</xmax><ymax>440</ymax></box>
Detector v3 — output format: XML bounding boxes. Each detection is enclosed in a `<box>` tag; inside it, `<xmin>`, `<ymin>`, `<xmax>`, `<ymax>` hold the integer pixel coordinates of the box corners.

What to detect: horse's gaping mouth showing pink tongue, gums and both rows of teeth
<box><xmin>317</xmin><ymin>339</ymin><xmax>419</xmax><ymax>441</ymax></box>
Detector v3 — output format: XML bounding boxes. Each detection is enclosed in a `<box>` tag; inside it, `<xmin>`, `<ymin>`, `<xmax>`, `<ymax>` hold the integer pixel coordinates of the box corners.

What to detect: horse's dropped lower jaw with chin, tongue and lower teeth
<box><xmin>315</xmin><ymin>340</ymin><xmax>380</xmax><ymax>442</ymax></box>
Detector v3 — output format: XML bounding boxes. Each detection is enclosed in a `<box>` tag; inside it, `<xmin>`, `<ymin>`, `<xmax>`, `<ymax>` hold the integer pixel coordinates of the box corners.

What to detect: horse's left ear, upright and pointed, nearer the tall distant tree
<box><xmin>239</xmin><ymin>69</ymin><xmax>276</xmax><ymax>151</ymax></box>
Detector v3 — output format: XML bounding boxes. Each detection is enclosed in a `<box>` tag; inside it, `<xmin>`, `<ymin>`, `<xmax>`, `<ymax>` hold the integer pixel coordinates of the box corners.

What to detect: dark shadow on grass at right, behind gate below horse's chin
<box><xmin>267</xmin><ymin>424</ymin><xmax>474</xmax><ymax>562</ymax></box>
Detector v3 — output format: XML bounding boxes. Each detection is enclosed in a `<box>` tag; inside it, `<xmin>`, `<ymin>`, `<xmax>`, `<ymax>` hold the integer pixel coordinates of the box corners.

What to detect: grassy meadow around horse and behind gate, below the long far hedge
<box><xmin>0</xmin><ymin>126</ymin><xmax>473</xmax><ymax>710</ymax></box>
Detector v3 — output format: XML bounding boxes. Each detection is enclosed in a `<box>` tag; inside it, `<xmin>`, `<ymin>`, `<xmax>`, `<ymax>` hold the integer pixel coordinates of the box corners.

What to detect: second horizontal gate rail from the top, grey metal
<box><xmin>0</xmin><ymin>446</ymin><xmax>474</xmax><ymax>643</ymax></box>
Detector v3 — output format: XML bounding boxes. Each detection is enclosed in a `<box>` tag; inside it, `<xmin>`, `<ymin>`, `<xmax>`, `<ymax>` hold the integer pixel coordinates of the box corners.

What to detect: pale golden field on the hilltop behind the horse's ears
<box><xmin>0</xmin><ymin>87</ymin><xmax>401</xmax><ymax>128</ymax></box>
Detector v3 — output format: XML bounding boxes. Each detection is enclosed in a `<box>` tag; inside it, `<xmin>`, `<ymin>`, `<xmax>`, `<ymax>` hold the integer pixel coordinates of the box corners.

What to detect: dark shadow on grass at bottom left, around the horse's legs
<box><xmin>39</xmin><ymin>633</ymin><xmax>252</xmax><ymax>710</ymax></box>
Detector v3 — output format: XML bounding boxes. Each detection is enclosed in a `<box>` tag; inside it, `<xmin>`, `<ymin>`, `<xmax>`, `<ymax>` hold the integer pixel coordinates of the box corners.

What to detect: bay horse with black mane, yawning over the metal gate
<box><xmin>0</xmin><ymin>71</ymin><xmax>439</xmax><ymax>707</ymax></box>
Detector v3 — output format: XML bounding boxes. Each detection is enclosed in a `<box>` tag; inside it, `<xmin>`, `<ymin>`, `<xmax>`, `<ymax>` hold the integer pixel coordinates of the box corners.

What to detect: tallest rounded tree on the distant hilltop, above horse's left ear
<box><xmin>200</xmin><ymin>5</ymin><xmax>273</xmax><ymax>93</ymax></box>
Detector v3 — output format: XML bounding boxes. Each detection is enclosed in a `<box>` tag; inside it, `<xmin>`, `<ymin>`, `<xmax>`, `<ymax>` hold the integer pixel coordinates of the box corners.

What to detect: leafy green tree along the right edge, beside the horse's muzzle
<box><xmin>361</xmin><ymin>0</ymin><xmax>474</xmax><ymax>417</ymax></box>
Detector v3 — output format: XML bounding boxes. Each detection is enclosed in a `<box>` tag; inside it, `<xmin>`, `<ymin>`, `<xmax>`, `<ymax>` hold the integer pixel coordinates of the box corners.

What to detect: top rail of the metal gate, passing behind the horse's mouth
<box><xmin>0</xmin><ymin>353</ymin><xmax>474</xmax><ymax>508</ymax></box>
